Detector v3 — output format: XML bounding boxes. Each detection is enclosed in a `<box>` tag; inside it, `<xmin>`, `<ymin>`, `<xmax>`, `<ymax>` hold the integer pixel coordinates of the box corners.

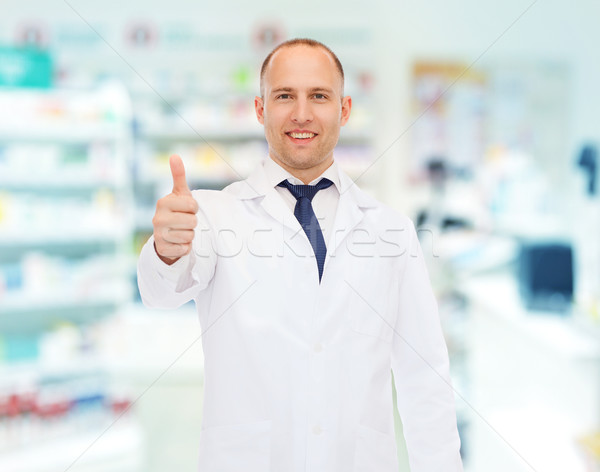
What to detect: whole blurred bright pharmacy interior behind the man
<box><xmin>0</xmin><ymin>0</ymin><xmax>600</xmax><ymax>472</ymax></box>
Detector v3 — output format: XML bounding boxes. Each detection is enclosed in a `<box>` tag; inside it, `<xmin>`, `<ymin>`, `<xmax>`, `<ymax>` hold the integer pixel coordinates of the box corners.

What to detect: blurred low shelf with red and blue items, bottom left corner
<box><xmin>0</xmin><ymin>346</ymin><xmax>142</xmax><ymax>472</ymax></box>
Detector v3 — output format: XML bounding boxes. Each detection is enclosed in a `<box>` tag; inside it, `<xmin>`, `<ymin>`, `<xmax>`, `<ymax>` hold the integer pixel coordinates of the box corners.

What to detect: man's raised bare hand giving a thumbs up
<box><xmin>152</xmin><ymin>154</ymin><xmax>198</xmax><ymax>265</ymax></box>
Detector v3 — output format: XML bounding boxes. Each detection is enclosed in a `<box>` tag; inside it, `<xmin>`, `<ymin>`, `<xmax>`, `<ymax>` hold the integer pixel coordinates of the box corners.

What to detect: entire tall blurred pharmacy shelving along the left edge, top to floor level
<box><xmin>0</xmin><ymin>83</ymin><xmax>143</xmax><ymax>472</ymax></box>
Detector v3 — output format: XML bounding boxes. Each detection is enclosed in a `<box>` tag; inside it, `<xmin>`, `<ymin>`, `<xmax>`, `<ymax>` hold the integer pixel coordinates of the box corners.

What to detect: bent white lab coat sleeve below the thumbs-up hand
<box><xmin>137</xmin><ymin>204</ymin><xmax>217</xmax><ymax>308</ymax></box>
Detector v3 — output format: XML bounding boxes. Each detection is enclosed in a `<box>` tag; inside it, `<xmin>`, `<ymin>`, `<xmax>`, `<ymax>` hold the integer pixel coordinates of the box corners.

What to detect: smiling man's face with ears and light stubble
<box><xmin>254</xmin><ymin>45</ymin><xmax>352</xmax><ymax>174</ymax></box>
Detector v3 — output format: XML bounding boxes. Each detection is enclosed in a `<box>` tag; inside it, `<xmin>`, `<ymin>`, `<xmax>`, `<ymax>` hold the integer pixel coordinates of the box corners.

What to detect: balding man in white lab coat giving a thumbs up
<box><xmin>138</xmin><ymin>39</ymin><xmax>462</xmax><ymax>472</ymax></box>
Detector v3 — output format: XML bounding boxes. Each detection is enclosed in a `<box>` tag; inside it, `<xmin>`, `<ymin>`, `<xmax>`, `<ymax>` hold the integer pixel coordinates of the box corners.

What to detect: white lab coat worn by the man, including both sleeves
<box><xmin>138</xmin><ymin>160</ymin><xmax>462</xmax><ymax>472</ymax></box>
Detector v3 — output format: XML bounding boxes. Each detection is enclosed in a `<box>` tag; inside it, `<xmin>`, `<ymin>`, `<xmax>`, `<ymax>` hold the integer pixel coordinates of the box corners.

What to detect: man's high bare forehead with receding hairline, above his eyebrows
<box><xmin>264</xmin><ymin>45</ymin><xmax>342</xmax><ymax>93</ymax></box>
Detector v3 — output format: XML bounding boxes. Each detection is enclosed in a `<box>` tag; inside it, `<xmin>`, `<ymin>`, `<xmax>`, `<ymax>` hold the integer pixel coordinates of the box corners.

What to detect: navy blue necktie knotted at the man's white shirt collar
<box><xmin>278</xmin><ymin>179</ymin><xmax>333</xmax><ymax>283</ymax></box>
